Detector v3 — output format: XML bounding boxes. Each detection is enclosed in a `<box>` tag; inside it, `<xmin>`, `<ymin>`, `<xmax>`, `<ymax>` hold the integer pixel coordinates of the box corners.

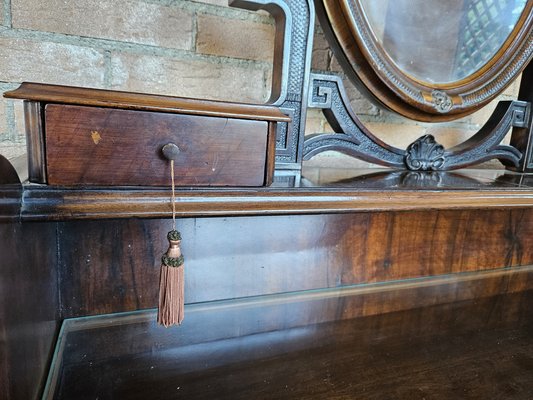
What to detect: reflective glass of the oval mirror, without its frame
<box><xmin>359</xmin><ymin>0</ymin><xmax>527</xmax><ymax>84</ymax></box>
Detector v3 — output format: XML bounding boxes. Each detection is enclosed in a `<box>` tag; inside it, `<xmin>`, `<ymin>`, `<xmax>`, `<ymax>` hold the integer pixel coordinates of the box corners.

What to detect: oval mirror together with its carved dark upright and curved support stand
<box><xmin>234</xmin><ymin>0</ymin><xmax>533</xmax><ymax>172</ymax></box>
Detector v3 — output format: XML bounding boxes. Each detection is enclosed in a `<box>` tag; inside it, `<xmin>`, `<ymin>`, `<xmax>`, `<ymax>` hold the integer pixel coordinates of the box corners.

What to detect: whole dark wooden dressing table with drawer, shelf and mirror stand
<box><xmin>0</xmin><ymin>0</ymin><xmax>533</xmax><ymax>400</ymax></box>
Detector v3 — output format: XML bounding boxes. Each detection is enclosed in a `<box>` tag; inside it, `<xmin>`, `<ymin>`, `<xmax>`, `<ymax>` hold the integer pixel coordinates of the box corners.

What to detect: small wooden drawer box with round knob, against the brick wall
<box><xmin>5</xmin><ymin>83</ymin><xmax>289</xmax><ymax>186</ymax></box>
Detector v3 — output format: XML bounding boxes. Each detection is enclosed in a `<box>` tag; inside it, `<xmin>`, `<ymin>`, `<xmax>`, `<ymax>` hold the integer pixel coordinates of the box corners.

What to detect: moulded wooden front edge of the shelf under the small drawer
<box><xmin>14</xmin><ymin>186</ymin><xmax>533</xmax><ymax>221</ymax></box>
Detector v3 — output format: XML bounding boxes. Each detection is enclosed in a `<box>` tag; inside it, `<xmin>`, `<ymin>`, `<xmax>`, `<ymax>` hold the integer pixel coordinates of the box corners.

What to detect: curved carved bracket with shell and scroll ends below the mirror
<box><xmin>304</xmin><ymin>74</ymin><xmax>530</xmax><ymax>171</ymax></box>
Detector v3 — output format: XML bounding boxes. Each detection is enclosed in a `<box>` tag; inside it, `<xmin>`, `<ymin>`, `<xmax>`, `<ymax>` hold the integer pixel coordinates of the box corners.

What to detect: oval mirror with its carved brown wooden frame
<box><xmin>316</xmin><ymin>0</ymin><xmax>533</xmax><ymax>121</ymax></box>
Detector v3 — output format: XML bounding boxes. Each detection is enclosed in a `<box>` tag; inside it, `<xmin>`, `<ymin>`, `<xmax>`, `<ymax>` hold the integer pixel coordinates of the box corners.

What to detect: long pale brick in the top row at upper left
<box><xmin>12</xmin><ymin>0</ymin><xmax>192</xmax><ymax>50</ymax></box>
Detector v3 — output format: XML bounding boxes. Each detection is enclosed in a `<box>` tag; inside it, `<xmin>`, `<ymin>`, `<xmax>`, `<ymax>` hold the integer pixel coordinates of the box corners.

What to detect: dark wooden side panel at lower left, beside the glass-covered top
<box><xmin>0</xmin><ymin>223</ymin><xmax>59</xmax><ymax>400</ymax></box>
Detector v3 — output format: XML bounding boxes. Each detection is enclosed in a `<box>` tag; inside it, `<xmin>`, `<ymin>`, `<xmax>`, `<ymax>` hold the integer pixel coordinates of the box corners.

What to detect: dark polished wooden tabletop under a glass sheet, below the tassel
<box><xmin>48</xmin><ymin>282</ymin><xmax>533</xmax><ymax>400</ymax></box>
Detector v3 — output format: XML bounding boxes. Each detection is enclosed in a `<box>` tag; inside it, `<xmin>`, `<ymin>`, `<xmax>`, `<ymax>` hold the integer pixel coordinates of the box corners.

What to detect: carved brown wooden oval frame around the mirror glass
<box><xmin>315</xmin><ymin>0</ymin><xmax>533</xmax><ymax>122</ymax></box>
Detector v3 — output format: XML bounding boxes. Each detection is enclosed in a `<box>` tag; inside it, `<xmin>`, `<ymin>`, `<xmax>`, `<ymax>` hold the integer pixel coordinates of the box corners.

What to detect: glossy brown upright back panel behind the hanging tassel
<box><xmin>59</xmin><ymin>209</ymin><xmax>533</xmax><ymax>317</ymax></box>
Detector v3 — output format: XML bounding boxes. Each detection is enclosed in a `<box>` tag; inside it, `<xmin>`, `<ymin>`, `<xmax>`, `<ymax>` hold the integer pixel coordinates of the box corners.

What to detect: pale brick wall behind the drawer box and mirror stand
<box><xmin>0</xmin><ymin>0</ymin><xmax>517</xmax><ymax>166</ymax></box>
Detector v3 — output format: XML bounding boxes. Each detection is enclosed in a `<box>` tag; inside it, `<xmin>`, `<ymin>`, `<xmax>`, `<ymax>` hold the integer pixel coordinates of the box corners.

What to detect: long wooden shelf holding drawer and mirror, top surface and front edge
<box><xmin>6</xmin><ymin>168</ymin><xmax>533</xmax><ymax>220</ymax></box>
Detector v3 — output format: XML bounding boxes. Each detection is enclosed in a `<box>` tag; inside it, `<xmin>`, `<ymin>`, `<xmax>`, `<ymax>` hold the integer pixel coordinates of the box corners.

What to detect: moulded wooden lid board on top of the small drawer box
<box><xmin>4</xmin><ymin>82</ymin><xmax>291</xmax><ymax>122</ymax></box>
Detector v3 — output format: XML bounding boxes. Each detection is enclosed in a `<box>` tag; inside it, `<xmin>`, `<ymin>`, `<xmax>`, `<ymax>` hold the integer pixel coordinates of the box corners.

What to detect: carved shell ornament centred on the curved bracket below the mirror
<box><xmin>405</xmin><ymin>135</ymin><xmax>446</xmax><ymax>171</ymax></box>
